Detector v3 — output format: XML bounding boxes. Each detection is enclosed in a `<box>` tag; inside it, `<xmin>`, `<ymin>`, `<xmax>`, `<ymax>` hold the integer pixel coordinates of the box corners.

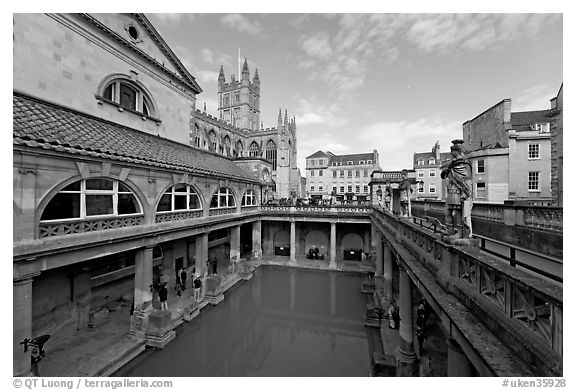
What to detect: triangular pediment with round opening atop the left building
<box><xmin>81</xmin><ymin>13</ymin><xmax>202</xmax><ymax>93</ymax></box>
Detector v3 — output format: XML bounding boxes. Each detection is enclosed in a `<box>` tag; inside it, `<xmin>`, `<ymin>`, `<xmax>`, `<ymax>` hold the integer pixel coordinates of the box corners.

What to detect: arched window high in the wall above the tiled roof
<box><xmin>102</xmin><ymin>77</ymin><xmax>156</xmax><ymax>117</ymax></box>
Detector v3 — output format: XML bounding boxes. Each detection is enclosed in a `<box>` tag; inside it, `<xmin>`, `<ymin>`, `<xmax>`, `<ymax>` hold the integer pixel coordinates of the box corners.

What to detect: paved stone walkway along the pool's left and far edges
<box><xmin>39</xmin><ymin>256</ymin><xmax>390</xmax><ymax>377</ymax></box>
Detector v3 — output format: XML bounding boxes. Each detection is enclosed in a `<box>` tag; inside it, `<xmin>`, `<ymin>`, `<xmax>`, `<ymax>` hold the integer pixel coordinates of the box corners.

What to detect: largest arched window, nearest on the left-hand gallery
<box><xmin>40</xmin><ymin>178</ymin><xmax>142</xmax><ymax>221</ymax></box>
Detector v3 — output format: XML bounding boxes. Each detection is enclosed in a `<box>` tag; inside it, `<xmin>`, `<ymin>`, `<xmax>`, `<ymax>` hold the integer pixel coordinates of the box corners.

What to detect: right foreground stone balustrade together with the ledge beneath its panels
<box><xmin>372</xmin><ymin>210</ymin><xmax>563</xmax><ymax>375</ymax></box>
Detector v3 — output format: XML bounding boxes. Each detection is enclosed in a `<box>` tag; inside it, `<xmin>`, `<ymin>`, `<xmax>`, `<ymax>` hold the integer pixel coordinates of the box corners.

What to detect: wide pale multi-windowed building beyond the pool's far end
<box><xmin>306</xmin><ymin>150</ymin><xmax>380</xmax><ymax>201</ymax></box>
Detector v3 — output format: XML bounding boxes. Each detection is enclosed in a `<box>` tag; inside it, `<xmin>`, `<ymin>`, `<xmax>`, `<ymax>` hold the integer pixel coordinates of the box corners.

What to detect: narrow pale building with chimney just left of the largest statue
<box><xmin>413</xmin><ymin>141</ymin><xmax>451</xmax><ymax>200</ymax></box>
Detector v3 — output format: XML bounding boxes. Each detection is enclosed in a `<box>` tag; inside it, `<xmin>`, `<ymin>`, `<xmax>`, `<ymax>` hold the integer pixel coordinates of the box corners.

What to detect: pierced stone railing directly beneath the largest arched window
<box><xmin>38</xmin><ymin>215</ymin><xmax>144</xmax><ymax>238</ymax></box>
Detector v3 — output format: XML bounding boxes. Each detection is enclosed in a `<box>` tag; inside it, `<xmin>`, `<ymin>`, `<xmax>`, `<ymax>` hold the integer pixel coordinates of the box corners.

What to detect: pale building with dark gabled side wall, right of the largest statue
<box><xmin>463</xmin><ymin>99</ymin><xmax>551</xmax><ymax>204</ymax></box>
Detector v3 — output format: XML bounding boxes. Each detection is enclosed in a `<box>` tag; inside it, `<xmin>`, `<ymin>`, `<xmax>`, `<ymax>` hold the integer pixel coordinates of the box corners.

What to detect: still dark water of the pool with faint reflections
<box><xmin>116</xmin><ymin>267</ymin><xmax>370</xmax><ymax>377</ymax></box>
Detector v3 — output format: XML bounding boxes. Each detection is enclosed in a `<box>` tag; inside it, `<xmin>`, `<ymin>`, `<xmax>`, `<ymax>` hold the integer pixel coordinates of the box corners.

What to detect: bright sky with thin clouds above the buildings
<box><xmin>146</xmin><ymin>13</ymin><xmax>563</xmax><ymax>173</ymax></box>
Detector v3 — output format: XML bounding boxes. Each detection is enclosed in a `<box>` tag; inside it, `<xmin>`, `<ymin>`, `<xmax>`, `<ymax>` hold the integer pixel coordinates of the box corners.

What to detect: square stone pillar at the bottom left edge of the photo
<box><xmin>12</xmin><ymin>273</ymin><xmax>42</xmax><ymax>376</ymax></box>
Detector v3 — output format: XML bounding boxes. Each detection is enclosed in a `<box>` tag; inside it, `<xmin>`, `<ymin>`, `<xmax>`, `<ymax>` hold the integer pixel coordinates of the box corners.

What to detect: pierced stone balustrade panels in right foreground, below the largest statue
<box><xmin>374</xmin><ymin>210</ymin><xmax>563</xmax><ymax>362</ymax></box>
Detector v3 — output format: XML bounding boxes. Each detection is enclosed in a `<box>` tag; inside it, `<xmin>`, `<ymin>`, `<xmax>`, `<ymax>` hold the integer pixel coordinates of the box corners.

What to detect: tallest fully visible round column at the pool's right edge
<box><xmin>398</xmin><ymin>267</ymin><xmax>416</xmax><ymax>375</ymax></box>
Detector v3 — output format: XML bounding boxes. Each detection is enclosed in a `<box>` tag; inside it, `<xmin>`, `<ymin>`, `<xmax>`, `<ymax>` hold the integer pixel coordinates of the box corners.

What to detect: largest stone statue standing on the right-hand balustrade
<box><xmin>440</xmin><ymin>140</ymin><xmax>472</xmax><ymax>244</ymax></box>
